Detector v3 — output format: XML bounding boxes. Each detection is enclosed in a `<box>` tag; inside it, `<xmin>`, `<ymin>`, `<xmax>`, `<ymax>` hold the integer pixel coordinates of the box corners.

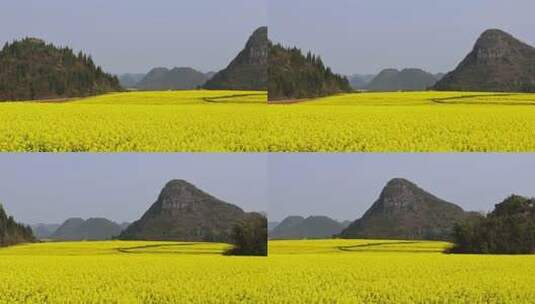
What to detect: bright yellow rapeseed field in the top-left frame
<box><xmin>0</xmin><ymin>90</ymin><xmax>268</xmax><ymax>152</ymax></box>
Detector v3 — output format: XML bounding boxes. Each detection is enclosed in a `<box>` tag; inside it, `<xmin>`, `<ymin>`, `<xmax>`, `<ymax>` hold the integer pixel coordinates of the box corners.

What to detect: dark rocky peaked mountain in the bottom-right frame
<box><xmin>340</xmin><ymin>178</ymin><xmax>470</xmax><ymax>240</ymax></box>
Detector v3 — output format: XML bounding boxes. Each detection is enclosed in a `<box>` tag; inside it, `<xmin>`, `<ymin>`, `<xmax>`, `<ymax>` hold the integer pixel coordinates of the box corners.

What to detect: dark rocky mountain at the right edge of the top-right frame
<box><xmin>434</xmin><ymin>29</ymin><xmax>535</xmax><ymax>92</ymax></box>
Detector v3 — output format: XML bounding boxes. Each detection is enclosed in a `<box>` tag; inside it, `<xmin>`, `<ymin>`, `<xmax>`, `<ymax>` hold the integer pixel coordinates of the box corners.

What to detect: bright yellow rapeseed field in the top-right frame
<box><xmin>267</xmin><ymin>92</ymin><xmax>535</xmax><ymax>152</ymax></box>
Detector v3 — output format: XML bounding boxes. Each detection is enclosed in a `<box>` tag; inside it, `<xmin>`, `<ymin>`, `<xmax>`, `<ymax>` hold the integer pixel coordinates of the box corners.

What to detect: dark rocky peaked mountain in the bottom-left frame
<box><xmin>119</xmin><ymin>180</ymin><xmax>247</xmax><ymax>242</ymax></box>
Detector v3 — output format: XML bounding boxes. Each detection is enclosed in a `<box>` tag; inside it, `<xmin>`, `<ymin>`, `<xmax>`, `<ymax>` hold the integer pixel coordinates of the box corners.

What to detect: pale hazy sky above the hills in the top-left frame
<box><xmin>0</xmin><ymin>0</ymin><xmax>267</xmax><ymax>74</ymax></box>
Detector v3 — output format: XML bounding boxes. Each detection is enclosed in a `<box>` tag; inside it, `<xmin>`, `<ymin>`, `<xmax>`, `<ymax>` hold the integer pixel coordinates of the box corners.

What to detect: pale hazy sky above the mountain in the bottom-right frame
<box><xmin>267</xmin><ymin>153</ymin><xmax>535</xmax><ymax>221</ymax></box>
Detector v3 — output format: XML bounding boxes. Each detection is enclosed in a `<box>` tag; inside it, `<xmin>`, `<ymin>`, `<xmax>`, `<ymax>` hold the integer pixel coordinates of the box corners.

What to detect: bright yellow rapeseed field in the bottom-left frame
<box><xmin>0</xmin><ymin>241</ymin><xmax>266</xmax><ymax>303</ymax></box>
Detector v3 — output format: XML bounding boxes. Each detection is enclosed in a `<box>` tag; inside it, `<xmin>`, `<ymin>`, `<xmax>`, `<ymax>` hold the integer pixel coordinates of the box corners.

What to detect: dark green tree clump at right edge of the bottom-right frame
<box><xmin>450</xmin><ymin>195</ymin><xmax>535</xmax><ymax>254</ymax></box>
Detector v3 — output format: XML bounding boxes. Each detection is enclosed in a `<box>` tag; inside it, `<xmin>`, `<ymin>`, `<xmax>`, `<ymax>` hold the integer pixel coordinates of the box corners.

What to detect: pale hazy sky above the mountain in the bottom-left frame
<box><xmin>0</xmin><ymin>153</ymin><xmax>268</xmax><ymax>224</ymax></box>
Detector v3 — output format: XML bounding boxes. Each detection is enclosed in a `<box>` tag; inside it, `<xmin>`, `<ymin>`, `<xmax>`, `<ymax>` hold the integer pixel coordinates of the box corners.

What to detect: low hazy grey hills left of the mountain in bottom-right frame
<box><xmin>269</xmin><ymin>216</ymin><xmax>346</xmax><ymax>239</ymax></box>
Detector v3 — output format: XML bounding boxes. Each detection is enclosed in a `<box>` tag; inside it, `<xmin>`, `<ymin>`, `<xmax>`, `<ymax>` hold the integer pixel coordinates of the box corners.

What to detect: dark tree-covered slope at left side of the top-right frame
<box><xmin>268</xmin><ymin>44</ymin><xmax>352</xmax><ymax>100</ymax></box>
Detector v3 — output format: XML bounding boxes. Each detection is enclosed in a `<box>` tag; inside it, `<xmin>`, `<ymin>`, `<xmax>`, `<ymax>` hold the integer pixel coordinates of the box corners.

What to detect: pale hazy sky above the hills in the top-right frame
<box><xmin>268</xmin><ymin>0</ymin><xmax>535</xmax><ymax>75</ymax></box>
